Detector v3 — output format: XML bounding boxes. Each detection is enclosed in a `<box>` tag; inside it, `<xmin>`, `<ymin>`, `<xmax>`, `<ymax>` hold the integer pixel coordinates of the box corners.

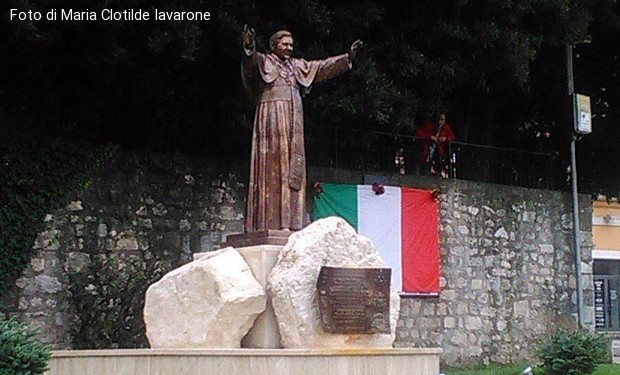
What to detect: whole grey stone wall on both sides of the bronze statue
<box><xmin>0</xmin><ymin>154</ymin><xmax>593</xmax><ymax>365</ymax></box>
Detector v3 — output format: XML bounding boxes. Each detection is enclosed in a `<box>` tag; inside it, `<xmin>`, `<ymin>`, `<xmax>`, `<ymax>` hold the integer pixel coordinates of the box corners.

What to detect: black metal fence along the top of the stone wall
<box><xmin>307</xmin><ymin>128</ymin><xmax>562</xmax><ymax>189</ymax></box>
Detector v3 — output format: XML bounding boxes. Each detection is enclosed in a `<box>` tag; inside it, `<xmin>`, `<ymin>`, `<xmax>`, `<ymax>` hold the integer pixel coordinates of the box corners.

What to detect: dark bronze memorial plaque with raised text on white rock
<box><xmin>317</xmin><ymin>267</ymin><xmax>392</xmax><ymax>334</ymax></box>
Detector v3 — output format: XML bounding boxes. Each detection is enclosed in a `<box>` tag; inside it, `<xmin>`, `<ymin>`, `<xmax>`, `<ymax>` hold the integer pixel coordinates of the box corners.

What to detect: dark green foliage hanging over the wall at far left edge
<box><xmin>0</xmin><ymin>135</ymin><xmax>117</xmax><ymax>294</ymax></box>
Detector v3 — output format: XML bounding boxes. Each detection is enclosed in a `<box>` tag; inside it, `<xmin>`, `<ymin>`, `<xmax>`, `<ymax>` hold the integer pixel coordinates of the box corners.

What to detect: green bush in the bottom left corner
<box><xmin>0</xmin><ymin>319</ymin><xmax>50</xmax><ymax>375</ymax></box>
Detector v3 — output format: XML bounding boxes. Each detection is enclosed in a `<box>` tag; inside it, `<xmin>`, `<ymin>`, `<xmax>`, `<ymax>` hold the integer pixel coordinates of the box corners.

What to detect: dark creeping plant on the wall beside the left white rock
<box><xmin>69</xmin><ymin>254</ymin><xmax>175</xmax><ymax>349</ymax></box>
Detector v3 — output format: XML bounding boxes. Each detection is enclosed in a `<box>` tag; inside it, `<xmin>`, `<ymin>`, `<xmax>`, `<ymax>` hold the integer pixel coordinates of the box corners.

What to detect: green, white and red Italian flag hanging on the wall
<box><xmin>314</xmin><ymin>183</ymin><xmax>439</xmax><ymax>296</ymax></box>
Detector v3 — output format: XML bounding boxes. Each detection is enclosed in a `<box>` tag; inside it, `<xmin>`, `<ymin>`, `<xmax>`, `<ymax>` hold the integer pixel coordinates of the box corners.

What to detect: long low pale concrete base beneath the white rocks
<box><xmin>45</xmin><ymin>348</ymin><xmax>442</xmax><ymax>375</ymax></box>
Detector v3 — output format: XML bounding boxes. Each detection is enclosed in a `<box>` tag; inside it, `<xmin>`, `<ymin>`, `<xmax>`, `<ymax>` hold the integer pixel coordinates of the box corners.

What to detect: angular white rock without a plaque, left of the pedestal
<box><xmin>144</xmin><ymin>247</ymin><xmax>267</xmax><ymax>348</ymax></box>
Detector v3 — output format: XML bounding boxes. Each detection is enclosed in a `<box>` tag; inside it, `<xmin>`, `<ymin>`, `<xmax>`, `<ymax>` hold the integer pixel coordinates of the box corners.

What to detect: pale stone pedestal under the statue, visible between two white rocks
<box><xmin>237</xmin><ymin>245</ymin><xmax>282</xmax><ymax>349</ymax></box>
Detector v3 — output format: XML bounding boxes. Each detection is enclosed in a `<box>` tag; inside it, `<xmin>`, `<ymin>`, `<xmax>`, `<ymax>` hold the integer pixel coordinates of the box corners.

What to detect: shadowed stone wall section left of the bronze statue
<box><xmin>0</xmin><ymin>153</ymin><xmax>245</xmax><ymax>349</ymax></box>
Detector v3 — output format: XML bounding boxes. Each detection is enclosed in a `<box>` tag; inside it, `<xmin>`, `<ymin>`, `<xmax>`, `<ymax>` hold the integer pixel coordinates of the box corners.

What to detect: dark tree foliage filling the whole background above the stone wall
<box><xmin>0</xmin><ymin>0</ymin><xmax>620</xmax><ymax>195</ymax></box>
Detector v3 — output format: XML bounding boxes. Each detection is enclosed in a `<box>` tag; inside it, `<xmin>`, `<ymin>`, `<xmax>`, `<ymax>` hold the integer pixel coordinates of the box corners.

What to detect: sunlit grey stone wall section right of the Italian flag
<box><xmin>398</xmin><ymin>178</ymin><xmax>594</xmax><ymax>364</ymax></box>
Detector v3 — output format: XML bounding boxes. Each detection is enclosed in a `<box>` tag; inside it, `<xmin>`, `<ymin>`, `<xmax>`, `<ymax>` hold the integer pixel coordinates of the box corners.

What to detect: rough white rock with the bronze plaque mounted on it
<box><xmin>268</xmin><ymin>217</ymin><xmax>400</xmax><ymax>349</ymax></box>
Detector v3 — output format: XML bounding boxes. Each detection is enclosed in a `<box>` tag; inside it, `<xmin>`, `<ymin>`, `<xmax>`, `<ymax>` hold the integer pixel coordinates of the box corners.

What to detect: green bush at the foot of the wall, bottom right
<box><xmin>537</xmin><ymin>329</ymin><xmax>607</xmax><ymax>375</ymax></box>
